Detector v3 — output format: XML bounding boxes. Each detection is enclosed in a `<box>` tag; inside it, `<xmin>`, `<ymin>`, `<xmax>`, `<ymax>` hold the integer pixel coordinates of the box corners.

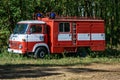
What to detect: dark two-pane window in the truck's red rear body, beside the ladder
<box><xmin>59</xmin><ymin>22</ymin><xmax>70</xmax><ymax>32</ymax></box>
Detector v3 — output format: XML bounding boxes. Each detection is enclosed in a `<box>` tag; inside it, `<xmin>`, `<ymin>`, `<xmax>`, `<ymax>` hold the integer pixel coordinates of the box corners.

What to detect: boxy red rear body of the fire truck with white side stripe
<box><xmin>42</xmin><ymin>18</ymin><xmax>105</xmax><ymax>53</ymax></box>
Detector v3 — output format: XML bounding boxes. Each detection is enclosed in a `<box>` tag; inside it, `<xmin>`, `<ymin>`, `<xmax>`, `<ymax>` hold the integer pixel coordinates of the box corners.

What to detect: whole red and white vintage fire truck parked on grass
<box><xmin>8</xmin><ymin>14</ymin><xmax>105</xmax><ymax>58</ymax></box>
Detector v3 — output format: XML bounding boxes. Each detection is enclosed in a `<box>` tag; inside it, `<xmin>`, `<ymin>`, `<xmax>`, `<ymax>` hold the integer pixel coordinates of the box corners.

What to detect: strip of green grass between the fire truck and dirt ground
<box><xmin>0</xmin><ymin>52</ymin><xmax>120</xmax><ymax>66</ymax></box>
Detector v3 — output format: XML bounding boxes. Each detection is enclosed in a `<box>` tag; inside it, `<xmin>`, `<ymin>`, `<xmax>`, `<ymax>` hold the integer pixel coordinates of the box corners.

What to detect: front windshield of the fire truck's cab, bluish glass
<box><xmin>14</xmin><ymin>24</ymin><xmax>28</xmax><ymax>34</ymax></box>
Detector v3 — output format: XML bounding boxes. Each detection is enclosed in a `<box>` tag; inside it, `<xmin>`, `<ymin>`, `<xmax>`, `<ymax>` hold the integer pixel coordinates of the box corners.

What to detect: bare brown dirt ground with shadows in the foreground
<box><xmin>0</xmin><ymin>63</ymin><xmax>120</xmax><ymax>80</ymax></box>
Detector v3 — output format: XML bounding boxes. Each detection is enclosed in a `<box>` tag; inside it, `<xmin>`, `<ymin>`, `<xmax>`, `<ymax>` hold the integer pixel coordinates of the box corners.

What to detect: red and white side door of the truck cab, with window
<box><xmin>27</xmin><ymin>24</ymin><xmax>44</xmax><ymax>52</ymax></box>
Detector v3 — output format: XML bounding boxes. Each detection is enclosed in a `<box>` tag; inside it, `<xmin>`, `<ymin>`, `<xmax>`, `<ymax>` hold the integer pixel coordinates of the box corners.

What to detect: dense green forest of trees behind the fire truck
<box><xmin>0</xmin><ymin>0</ymin><xmax>120</xmax><ymax>52</ymax></box>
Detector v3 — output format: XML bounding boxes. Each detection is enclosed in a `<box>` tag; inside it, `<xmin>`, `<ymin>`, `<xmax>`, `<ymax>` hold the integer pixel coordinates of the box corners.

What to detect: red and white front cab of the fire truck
<box><xmin>8</xmin><ymin>20</ymin><xmax>50</xmax><ymax>57</ymax></box>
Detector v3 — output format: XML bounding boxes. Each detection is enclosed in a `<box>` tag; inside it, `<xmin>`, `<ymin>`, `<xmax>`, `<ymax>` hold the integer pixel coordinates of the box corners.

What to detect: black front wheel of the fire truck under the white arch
<box><xmin>34</xmin><ymin>47</ymin><xmax>47</xmax><ymax>58</ymax></box>
